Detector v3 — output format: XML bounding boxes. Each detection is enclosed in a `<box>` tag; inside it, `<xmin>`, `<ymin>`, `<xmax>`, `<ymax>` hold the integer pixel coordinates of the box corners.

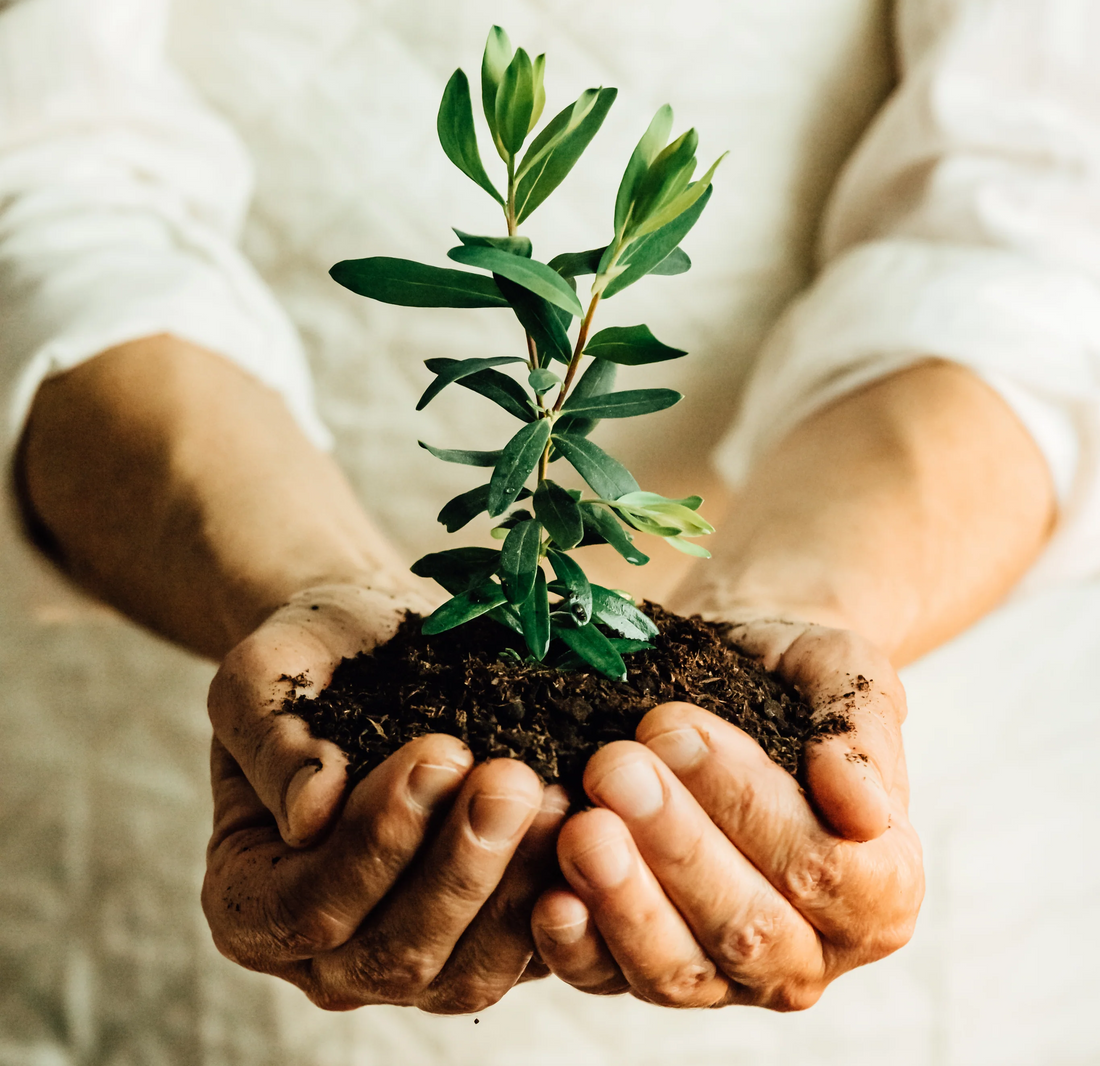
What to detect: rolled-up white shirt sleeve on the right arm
<box><xmin>718</xmin><ymin>0</ymin><xmax>1100</xmax><ymax>585</ymax></box>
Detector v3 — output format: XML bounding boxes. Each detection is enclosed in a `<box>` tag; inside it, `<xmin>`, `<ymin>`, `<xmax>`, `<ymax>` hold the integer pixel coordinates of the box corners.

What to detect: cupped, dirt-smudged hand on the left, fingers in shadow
<box><xmin>202</xmin><ymin>585</ymin><xmax>567</xmax><ymax>1013</ymax></box>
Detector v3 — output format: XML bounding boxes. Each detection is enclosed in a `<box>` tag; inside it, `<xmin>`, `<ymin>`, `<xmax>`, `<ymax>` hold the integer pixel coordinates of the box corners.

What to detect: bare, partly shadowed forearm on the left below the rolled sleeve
<box><xmin>18</xmin><ymin>337</ymin><xmax>413</xmax><ymax>657</ymax></box>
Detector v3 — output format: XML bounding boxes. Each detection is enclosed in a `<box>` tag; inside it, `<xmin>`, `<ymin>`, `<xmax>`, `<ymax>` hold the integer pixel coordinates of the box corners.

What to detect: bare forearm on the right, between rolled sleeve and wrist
<box><xmin>673</xmin><ymin>362</ymin><xmax>1055</xmax><ymax>663</ymax></box>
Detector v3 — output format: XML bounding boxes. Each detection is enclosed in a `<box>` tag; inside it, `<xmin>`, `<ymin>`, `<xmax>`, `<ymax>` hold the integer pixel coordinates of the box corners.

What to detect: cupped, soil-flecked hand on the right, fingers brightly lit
<box><xmin>532</xmin><ymin>622</ymin><xmax>924</xmax><ymax>1010</ymax></box>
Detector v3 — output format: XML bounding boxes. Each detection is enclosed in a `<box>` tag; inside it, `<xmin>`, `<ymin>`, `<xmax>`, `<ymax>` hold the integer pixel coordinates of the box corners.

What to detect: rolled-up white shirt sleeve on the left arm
<box><xmin>0</xmin><ymin>0</ymin><xmax>329</xmax><ymax>481</ymax></box>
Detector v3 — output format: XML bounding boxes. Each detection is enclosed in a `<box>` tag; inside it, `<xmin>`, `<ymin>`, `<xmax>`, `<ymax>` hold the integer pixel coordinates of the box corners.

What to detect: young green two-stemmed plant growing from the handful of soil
<box><xmin>331</xmin><ymin>26</ymin><xmax>721</xmax><ymax>680</ymax></box>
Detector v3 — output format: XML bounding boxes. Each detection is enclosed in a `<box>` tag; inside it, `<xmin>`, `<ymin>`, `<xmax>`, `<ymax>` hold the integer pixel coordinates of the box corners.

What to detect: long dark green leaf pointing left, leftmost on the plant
<box><xmin>329</xmin><ymin>253</ymin><xmax>508</xmax><ymax>307</ymax></box>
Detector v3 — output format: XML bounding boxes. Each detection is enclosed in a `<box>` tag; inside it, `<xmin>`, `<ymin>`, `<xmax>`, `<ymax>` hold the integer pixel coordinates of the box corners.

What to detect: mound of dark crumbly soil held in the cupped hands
<box><xmin>284</xmin><ymin>604</ymin><xmax>848</xmax><ymax>800</ymax></box>
